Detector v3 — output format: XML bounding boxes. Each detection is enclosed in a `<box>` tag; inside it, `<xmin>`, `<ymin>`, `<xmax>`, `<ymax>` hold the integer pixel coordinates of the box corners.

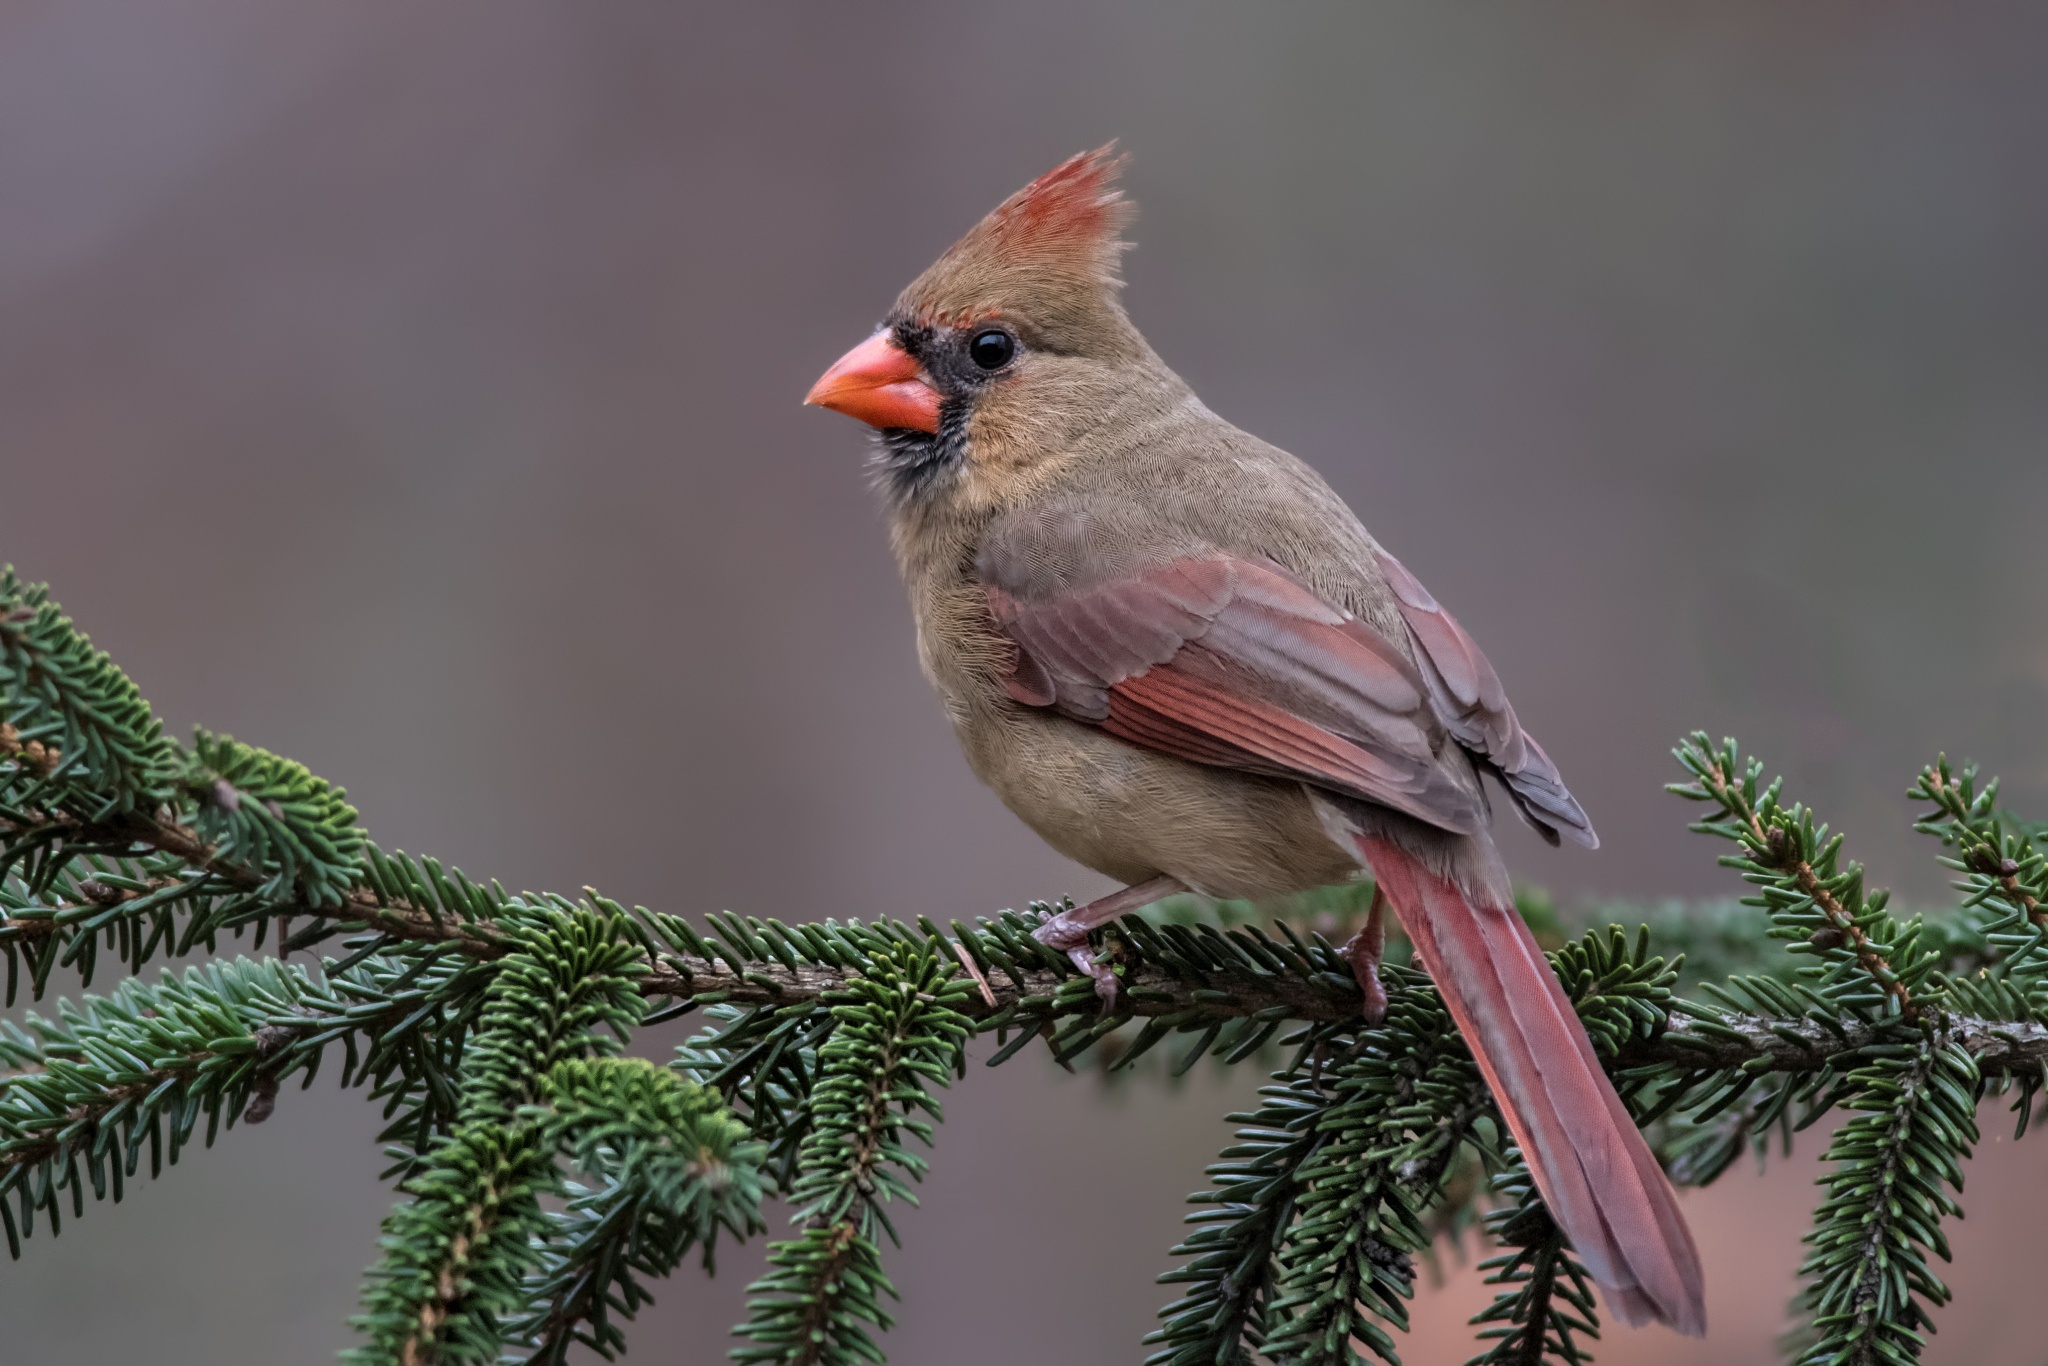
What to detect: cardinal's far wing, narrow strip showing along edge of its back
<box><xmin>1378</xmin><ymin>551</ymin><xmax>1599</xmax><ymax>848</ymax></box>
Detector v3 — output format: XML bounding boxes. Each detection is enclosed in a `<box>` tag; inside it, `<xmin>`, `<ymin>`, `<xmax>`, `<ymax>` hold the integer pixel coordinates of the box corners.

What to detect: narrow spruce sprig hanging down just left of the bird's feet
<box><xmin>731</xmin><ymin>942</ymin><xmax>971</xmax><ymax>1366</ymax></box>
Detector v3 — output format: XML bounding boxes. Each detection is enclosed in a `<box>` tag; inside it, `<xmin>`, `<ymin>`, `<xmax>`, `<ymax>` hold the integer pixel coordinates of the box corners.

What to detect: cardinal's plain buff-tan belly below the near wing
<box><xmin>961</xmin><ymin>709</ymin><xmax>1358</xmax><ymax>901</ymax></box>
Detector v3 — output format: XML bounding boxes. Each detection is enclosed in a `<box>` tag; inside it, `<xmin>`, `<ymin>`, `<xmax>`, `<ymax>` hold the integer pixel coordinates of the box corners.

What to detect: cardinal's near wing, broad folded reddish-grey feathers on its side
<box><xmin>983</xmin><ymin>551</ymin><xmax>1491</xmax><ymax>834</ymax></box>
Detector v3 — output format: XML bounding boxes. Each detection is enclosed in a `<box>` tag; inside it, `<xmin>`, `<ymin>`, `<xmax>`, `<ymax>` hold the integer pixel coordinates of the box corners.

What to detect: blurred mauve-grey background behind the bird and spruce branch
<box><xmin>0</xmin><ymin>0</ymin><xmax>2048</xmax><ymax>1366</ymax></box>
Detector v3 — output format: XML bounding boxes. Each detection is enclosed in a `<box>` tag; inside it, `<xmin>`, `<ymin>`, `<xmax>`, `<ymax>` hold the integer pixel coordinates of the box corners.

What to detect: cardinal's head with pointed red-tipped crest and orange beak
<box><xmin>805</xmin><ymin>143</ymin><xmax>1151</xmax><ymax>504</ymax></box>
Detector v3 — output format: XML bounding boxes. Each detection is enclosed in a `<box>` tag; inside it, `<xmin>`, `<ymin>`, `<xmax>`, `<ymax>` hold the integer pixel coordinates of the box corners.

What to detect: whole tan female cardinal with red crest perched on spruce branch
<box><xmin>805</xmin><ymin>147</ymin><xmax>1706</xmax><ymax>1333</ymax></box>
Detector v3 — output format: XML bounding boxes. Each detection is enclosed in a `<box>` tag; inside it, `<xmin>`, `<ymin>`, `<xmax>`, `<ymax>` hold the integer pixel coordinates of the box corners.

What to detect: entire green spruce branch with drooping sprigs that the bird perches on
<box><xmin>12</xmin><ymin>571</ymin><xmax>2048</xmax><ymax>1366</ymax></box>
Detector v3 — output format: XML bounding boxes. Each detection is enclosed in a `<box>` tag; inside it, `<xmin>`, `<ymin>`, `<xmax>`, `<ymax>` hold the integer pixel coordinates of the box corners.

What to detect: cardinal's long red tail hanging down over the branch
<box><xmin>1358</xmin><ymin>838</ymin><xmax>1706</xmax><ymax>1337</ymax></box>
